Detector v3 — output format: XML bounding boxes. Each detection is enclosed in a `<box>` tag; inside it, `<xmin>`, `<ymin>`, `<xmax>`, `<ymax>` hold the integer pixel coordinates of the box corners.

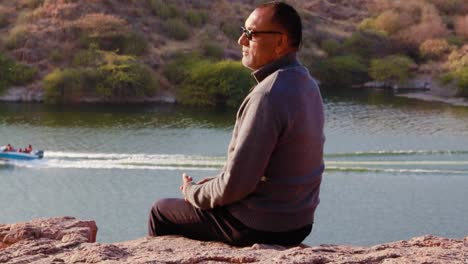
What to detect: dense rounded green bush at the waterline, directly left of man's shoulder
<box><xmin>177</xmin><ymin>60</ymin><xmax>253</xmax><ymax>107</ymax></box>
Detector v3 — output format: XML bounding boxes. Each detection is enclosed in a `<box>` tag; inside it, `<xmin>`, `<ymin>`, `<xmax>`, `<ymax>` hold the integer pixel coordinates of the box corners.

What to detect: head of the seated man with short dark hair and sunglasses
<box><xmin>238</xmin><ymin>2</ymin><xmax>302</xmax><ymax>70</ymax></box>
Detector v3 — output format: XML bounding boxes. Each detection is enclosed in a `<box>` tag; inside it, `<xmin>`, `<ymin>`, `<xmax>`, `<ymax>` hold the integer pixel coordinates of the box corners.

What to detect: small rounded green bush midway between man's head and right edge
<box><xmin>369</xmin><ymin>55</ymin><xmax>414</xmax><ymax>83</ymax></box>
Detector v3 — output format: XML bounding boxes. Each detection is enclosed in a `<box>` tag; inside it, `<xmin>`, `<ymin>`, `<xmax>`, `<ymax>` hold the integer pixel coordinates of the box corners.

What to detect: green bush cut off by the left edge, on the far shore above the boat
<box><xmin>0</xmin><ymin>53</ymin><xmax>37</xmax><ymax>93</ymax></box>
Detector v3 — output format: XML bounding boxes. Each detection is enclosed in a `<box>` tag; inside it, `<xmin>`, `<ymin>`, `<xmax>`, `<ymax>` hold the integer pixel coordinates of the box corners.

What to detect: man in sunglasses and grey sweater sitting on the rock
<box><xmin>148</xmin><ymin>2</ymin><xmax>325</xmax><ymax>246</ymax></box>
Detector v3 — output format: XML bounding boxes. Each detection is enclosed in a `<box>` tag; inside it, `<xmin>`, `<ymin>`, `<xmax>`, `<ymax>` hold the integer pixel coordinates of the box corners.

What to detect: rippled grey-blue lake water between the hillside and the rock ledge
<box><xmin>0</xmin><ymin>92</ymin><xmax>468</xmax><ymax>245</ymax></box>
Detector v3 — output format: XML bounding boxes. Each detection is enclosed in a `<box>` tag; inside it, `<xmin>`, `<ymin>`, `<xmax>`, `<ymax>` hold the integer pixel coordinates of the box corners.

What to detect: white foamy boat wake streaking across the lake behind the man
<box><xmin>0</xmin><ymin>150</ymin><xmax>468</xmax><ymax>176</ymax></box>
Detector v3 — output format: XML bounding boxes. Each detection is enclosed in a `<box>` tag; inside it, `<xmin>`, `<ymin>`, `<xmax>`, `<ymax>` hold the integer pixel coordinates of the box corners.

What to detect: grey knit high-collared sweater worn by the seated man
<box><xmin>185</xmin><ymin>53</ymin><xmax>325</xmax><ymax>232</ymax></box>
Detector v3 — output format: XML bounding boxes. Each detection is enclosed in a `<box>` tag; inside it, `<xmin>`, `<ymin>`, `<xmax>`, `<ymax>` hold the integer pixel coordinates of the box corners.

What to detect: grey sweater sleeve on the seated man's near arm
<box><xmin>185</xmin><ymin>92</ymin><xmax>281</xmax><ymax>209</ymax></box>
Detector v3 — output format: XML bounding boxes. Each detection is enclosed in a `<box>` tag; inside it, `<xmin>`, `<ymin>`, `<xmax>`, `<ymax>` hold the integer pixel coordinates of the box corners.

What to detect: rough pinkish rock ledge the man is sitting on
<box><xmin>0</xmin><ymin>217</ymin><xmax>468</xmax><ymax>264</ymax></box>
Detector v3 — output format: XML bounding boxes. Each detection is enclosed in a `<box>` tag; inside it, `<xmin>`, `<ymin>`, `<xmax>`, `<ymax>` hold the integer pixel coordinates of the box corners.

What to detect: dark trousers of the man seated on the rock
<box><xmin>148</xmin><ymin>199</ymin><xmax>312</xmax><ymax>246</ymax></box>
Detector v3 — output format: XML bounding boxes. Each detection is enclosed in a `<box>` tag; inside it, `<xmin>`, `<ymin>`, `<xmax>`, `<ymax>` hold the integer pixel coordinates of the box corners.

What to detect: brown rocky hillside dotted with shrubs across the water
<box><xmin>0</xmin><ymin>0</ymin><xmax>468</xmax><ymax>105</ymax></box>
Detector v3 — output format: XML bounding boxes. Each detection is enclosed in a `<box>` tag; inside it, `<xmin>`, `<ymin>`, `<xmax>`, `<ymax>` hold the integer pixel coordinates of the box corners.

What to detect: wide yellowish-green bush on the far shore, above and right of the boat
<box><xmin>43</xmin><ymin>50</ymin><xmax>158</xmax><ymax>103</ymax></box>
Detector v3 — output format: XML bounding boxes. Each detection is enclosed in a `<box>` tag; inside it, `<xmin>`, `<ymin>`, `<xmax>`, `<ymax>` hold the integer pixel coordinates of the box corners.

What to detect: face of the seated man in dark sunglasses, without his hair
<box><xmin>238</xmin><ymin>8</ymin><xmax>282</xmax><ymax>70</ymax></box>
